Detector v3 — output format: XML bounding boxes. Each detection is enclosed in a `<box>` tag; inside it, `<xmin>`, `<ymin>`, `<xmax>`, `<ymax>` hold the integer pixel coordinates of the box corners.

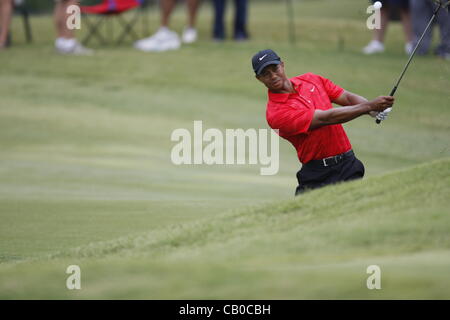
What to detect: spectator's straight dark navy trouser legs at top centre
<box><xmin>213</xmin><ymin>0</ymin><xmax>248</xmax><ymax>41</ymax></box>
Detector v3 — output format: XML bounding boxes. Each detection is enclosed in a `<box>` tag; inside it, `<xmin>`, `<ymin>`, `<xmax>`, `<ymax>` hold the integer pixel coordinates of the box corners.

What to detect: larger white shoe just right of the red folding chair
<box><xmin>134</xmin><ymin>27</ymin><xmax>181</xmax><ymax>52</ymax></box>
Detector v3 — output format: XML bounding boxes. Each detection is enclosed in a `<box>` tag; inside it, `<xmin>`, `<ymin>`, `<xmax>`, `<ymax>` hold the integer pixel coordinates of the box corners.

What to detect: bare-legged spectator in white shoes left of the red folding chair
<box><xmin>53</xmin><ymin>0</ymin><xmax>92</xmax><ymax>55</ymax></box>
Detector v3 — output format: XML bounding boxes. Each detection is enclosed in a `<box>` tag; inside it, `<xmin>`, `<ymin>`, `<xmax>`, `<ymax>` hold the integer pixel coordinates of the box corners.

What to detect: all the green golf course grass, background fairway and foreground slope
<box><xmin>0</xmin><ymin>0</ymin><xmax>450</xmax><ymax>298</ymax></box>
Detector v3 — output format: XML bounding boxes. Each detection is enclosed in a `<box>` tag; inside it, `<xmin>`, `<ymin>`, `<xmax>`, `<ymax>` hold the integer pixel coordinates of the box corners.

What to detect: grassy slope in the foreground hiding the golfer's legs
<box><xmin>0</xmin><ymin>159</ymin><xmax>450</xmax><ymax>299</ymax></box>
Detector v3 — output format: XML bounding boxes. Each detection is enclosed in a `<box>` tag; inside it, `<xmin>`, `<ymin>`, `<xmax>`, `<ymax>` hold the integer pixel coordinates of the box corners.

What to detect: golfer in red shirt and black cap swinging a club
<box><xmin>252</xmin><ymin>50</ymin><xmax>394</xmax><ymax>195</ymax></box>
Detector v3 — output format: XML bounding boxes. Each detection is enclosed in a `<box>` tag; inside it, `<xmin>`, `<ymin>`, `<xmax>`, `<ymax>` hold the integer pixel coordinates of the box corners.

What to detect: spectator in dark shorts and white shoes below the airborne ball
<box><xmin>363</xmin><ymin>0</ymin><xmax>414</xmax><ymax>54</ymax></box>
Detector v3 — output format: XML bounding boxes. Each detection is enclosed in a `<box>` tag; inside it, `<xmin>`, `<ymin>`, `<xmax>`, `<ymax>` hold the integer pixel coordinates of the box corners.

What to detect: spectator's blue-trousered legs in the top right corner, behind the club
<box><xmin>411</xmin><ymin>0</ymin><xmax>450</xmax><ymax>60</ymax></box>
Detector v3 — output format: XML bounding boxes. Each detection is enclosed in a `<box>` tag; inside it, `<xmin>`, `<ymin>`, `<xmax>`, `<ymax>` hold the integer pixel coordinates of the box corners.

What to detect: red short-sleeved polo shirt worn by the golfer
<box><xmin>266</xmin><ymin>73</ymin><xmax>352</xmax><ymax>163</ymax></box>
